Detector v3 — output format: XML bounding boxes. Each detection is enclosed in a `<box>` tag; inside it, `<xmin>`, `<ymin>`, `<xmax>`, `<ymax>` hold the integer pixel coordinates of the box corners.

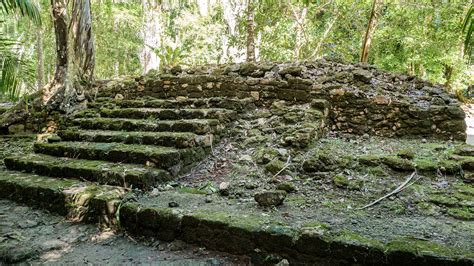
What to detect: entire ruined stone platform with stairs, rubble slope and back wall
<box><xmin>0</xmin><ymin>61</ymin><xmax>474</xmax><ymax>265</ymax></box>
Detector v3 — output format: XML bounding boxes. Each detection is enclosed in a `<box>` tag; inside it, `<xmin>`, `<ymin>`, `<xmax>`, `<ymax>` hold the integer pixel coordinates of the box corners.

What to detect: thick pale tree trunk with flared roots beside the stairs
<box><xmin>43</xmin><ymin>0</ymin><xmax>95</xmax><ymax>113</ymax></box>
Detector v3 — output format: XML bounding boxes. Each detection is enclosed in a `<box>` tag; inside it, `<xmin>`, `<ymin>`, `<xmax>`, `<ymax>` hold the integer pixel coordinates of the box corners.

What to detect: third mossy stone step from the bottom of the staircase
<box><xmin>34</xmin><ymin>141</ymin><xmax>206</xmax><ymax>175</ymax></box>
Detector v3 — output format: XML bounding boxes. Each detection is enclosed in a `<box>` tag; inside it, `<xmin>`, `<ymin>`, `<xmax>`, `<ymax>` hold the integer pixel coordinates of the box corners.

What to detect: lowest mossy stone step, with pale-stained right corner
<box><xmin>0</xmin><ymin>170</ymin><xmax>126</xmax><ymax>226</ymax></box>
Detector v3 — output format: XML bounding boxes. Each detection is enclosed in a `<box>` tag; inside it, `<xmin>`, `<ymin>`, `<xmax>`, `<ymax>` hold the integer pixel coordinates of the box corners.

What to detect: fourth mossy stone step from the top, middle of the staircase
<box><xmin>58</xmin><ymin>128</ymin><xmax>215</xmax><ymax>148</ymax></box>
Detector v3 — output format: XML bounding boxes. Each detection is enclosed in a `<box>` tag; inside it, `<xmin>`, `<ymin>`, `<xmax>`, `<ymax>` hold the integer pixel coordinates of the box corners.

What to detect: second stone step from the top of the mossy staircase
<box><xmin>100</xmin><ymin>108</ymin><xmax>237</xmax><ymax>121</ymax></box>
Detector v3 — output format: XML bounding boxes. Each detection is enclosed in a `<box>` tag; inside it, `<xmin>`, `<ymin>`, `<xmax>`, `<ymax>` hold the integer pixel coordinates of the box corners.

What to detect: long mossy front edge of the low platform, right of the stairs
<box><xmin>119</xmin><ymin>203</ymin><xmax>474</xmax><ymax>265</ymax></box>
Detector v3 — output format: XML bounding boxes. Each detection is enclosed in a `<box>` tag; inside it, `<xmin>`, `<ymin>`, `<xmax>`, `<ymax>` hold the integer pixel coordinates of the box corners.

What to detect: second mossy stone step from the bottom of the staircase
<box><xmin>4</xmin><ymin>154</ymin><xmax>171</xmax><ymax>189</ymax></box>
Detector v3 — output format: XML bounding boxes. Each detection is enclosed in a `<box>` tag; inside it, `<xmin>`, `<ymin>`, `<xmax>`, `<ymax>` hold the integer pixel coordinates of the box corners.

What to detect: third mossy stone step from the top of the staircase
<box><xmin>73</xmin><ymin>118</ymin><xmax>224</xmax><ymax>134</ymax></box>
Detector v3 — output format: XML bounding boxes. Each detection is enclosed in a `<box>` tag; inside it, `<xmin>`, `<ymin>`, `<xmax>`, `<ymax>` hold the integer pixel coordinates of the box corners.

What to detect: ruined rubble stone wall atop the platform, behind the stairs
<box><xmin>99</xmin><ymin>60</ymin><xmax>466</xmax><ymax>140</ymax></box>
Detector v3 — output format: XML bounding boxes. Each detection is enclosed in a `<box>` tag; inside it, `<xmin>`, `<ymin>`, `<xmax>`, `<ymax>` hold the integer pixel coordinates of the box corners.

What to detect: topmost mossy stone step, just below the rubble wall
<box><xmin>92</xmin><ymin>97</ymin><xmax>255</xmax><ymax>112</ymax></box>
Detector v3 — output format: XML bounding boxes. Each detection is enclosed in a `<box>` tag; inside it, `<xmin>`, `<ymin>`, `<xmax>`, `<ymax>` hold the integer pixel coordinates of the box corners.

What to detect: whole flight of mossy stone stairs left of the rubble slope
<box><xmin>0</xmin><ymin>97</ymin><xmax>253</xmax><ymax>225</ymax></box>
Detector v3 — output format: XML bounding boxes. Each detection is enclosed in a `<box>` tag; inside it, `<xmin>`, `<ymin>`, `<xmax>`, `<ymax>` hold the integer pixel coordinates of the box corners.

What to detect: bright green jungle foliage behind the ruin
<box><xmin>0</xmin><ymin>0</ymin><xmax>474</xmax><ymax>99</ymax></box>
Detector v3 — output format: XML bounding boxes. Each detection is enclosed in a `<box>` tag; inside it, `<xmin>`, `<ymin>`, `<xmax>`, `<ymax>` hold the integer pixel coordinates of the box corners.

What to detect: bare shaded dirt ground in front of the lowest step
<box><xmin>0</xmin><ymin>197</ymin><xmax>248</xmax><ymax>265</ymax></box>
